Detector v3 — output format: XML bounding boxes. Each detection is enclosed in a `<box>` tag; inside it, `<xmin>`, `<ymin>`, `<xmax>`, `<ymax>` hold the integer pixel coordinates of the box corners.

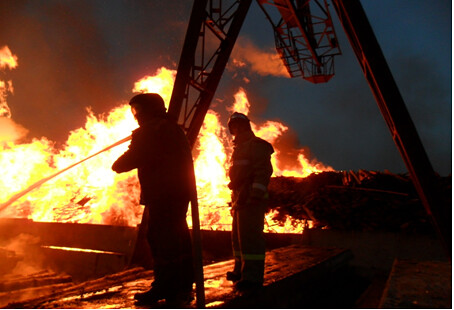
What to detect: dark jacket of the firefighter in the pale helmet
<box><xmin>229</xmin><ymin>131</ymin><xmax>274</xmax><ymax>209</ymax></box>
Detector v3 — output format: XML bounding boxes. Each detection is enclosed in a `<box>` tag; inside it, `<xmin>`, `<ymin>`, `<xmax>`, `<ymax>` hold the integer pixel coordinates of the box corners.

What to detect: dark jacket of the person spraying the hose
<box><xmin>112</xmin><ymin>118</ymin><xmax>194</xmax><ymax>212</ymax></box>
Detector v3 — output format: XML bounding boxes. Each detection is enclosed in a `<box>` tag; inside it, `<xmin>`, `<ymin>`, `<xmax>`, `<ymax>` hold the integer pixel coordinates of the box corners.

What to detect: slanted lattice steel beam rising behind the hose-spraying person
<box><xmin>169</xmin><ymin>0</ymin><xmax>252</xmax><ymax>146</ymax></box>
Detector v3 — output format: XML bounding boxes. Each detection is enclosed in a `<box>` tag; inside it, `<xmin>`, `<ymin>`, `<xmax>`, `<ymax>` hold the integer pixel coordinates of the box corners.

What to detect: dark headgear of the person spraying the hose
<box><xmin>129</xmin><ymin>93</ymin><xmax>166</xmax><ymax>118</ymax></box>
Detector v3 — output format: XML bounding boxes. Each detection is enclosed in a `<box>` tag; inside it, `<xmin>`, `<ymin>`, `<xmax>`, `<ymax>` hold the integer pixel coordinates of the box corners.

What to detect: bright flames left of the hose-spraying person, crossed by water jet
<box><xmin>0</xmin><ymin>105</ymin><xmax>141</xmax><ymax>225</ymax></box>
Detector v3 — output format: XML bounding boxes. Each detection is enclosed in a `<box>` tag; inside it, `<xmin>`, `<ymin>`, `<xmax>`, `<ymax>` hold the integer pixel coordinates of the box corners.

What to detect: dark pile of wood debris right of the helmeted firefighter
<box><xmin>269</xmin><ymin>170</ymin><xmax>451</xmax><ymax>233</ymax></box>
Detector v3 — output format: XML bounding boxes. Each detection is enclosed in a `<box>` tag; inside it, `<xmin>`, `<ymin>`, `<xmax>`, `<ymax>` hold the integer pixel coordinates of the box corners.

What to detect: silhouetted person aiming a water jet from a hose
<box><xmin>112</xmin><ymin>93</ymin><xmax>195</xmax><ymax>304</ymax></box>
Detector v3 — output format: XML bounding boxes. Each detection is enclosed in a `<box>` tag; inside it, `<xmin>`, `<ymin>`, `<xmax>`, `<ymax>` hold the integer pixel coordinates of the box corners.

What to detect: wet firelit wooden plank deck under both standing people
<box><xmin>8</xmin><ymin>245</ymin><xmax>351</xmax><ymax>309</ymax></box>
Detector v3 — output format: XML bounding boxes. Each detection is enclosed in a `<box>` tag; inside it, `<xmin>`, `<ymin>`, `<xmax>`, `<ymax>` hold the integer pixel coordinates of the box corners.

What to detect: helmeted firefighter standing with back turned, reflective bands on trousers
<box><xmin>227</xmin><ymin>112</ymin><xmax>274</xmax><ymax>291</ymax></box>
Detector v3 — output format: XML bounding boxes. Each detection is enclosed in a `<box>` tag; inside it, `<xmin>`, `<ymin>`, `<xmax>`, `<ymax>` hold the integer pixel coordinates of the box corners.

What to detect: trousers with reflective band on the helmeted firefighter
<box><xmin>232</xmin><ymin>202</ymin><xmax>266</xmax><ymax>283</ymax></box>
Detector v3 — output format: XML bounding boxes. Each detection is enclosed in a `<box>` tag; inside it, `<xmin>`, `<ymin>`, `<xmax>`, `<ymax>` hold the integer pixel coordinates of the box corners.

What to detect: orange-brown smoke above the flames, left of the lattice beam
<box><xmin>0</xmin><ymin>0</ymin><xmax>191</xmax><ymax>146</ymax></box>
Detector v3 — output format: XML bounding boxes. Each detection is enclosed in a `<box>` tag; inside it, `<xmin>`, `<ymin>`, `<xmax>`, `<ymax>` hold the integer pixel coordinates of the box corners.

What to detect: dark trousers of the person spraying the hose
<box><xmin>147</xmin><ymin>201</ymin><xmax>194</xmax><ymax>292</ymax></box>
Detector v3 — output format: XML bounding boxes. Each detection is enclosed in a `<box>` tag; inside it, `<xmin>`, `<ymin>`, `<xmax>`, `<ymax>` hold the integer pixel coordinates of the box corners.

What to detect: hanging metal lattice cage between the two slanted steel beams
<box><xmin>257</xmin><ymin>0</ymin><xmax>341</xmax><ymax>83</ymax></box>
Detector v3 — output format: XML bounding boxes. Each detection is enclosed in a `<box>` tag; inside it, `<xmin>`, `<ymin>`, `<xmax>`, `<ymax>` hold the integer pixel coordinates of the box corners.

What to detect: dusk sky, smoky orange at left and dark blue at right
<box><xmin>0</xmin><ymin>0</ymin><xmax>452</xmax><ymax>175</ymax></box>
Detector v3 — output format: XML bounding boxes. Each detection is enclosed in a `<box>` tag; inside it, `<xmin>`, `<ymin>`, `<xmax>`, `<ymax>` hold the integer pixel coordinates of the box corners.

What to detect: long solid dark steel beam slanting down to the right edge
<box><xmin>332</xmin><ymin>0</ymin><xmax>452</xmax><ymax>255</ymax></box>
